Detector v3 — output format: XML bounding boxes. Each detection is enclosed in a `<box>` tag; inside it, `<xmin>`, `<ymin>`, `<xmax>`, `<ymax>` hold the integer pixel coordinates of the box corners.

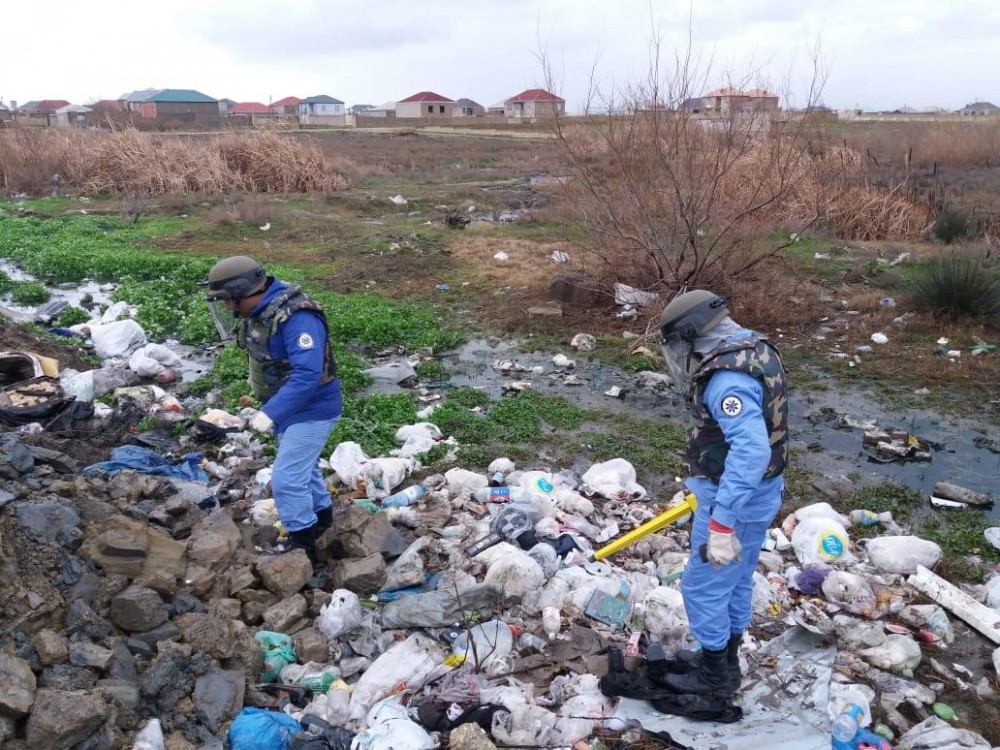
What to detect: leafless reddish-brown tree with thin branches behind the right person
<box><xmin>539</xmin><ymin>26</ymin><xmax>830</xmax><ymax>291</ymax></box>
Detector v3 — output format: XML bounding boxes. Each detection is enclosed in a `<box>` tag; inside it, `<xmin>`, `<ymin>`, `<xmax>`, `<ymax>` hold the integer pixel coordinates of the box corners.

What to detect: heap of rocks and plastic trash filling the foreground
<box><xmin>0</xmin><ymin>370</ymin><xmax>1000</xmax><ymax>750</ymax></box>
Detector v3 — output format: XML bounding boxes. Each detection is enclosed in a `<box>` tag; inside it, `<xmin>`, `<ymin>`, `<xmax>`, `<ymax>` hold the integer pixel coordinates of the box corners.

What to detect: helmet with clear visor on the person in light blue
<box><xmin>660</xmin><ymin>289</ymin><xmax>729</xmax><ymax>390</ymax></box>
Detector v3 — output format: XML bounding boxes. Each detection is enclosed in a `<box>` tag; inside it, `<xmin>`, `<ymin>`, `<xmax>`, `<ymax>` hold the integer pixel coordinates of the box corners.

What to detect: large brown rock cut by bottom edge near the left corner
<box><xmin>28</xmin><ymin>690</ymin><xmax>108</xmax><ymax>750</ymax></box>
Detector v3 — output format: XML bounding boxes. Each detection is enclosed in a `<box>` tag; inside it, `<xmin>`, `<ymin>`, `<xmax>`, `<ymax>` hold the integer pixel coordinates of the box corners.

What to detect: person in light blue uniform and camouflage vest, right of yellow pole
<box><xmin>660</xmin><ymin>289</ymin><xmax>788</xmax><ymax>698</ymax></box>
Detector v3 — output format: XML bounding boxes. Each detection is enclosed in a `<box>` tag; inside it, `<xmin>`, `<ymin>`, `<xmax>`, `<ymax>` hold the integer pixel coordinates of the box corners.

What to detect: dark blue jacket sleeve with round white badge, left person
<box><xmin>263</xmin><ymin>310</ymin><xmax>326</xmax><ymax>429</ymax></box>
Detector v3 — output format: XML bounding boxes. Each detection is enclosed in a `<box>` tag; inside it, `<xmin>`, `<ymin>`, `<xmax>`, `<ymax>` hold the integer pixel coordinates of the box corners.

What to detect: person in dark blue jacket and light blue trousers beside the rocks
<box><xmin>206</xmin><ymin>255</ymin><xmax>342</xmax><ymax>562</ymax></box>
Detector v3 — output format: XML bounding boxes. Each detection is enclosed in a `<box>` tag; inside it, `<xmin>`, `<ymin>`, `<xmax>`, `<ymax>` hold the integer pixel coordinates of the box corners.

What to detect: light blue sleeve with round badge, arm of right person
<box><xmin>704</xmin><ymin>370</ymin><xmax>771</xmax><ymax>528</ymax></box>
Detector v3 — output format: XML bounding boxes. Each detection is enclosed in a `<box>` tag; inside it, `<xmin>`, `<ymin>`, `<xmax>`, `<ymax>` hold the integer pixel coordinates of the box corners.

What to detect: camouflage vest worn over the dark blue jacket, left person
<box><xmin>236</xmin><ymin>286</ymin><xmax>337</xmax><ymax>402</ymax></box>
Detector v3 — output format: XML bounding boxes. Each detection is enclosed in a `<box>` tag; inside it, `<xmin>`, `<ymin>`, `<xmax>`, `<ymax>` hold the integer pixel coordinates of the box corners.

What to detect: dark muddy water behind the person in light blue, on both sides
<box><xmin>443</xmin><ymin>339</ymin><xmax>1000</xmax><ymax>517</ymax></box>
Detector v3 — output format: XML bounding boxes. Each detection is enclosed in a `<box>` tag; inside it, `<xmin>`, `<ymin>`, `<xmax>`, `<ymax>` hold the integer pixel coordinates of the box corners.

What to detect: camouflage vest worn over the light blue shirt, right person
<box><xmin>684</xmin><ymin>333</ymin><xmax>788</xmax><ymax>482</ymax></box>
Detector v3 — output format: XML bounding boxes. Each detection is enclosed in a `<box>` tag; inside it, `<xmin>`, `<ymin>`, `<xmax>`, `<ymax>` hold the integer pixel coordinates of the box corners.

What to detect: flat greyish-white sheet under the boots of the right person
<box><xmin>615</xmin><ymin>627</ymin><xmax>837</xmax><ymax>750</ymax></box>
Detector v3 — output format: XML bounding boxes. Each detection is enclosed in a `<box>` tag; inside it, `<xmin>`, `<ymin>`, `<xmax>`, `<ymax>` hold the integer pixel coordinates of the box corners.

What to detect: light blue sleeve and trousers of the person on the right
<box><xmin>681</xmin><ymin>370</ymin><xmax>785</xmax><ymax>650</ymax></box>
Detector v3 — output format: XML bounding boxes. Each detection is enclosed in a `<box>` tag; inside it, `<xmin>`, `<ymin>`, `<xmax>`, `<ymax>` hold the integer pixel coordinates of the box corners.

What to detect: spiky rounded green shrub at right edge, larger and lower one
<box><xmin>912</xmin><ymin>253</ymin><xmax>1000</xmax><ymax>318</ymax></box>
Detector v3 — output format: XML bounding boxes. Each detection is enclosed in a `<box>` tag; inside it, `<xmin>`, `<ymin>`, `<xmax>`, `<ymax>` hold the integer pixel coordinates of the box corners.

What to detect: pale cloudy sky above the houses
<box><xmin>0</xmin><ymin>0</ymin><xmax>1000</xmax><ymax>112</ymax></box>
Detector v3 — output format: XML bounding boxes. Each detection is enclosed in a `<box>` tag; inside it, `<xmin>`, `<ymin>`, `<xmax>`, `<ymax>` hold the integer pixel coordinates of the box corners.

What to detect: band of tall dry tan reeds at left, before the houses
<box><xmin>0</xmin><ymin>128</ymin><xmax>347</xmax><ymax>197</ymax></box>
